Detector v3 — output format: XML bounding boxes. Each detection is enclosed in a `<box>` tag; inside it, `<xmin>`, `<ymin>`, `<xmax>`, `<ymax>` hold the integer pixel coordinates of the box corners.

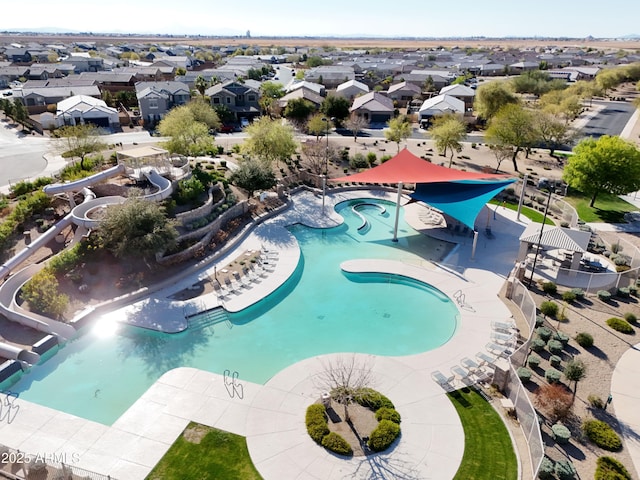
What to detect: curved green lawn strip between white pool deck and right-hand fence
<box><xmin>448</xmin><ymin>388</ymin><xmax>518</xmax><ymax>480</ymax></box>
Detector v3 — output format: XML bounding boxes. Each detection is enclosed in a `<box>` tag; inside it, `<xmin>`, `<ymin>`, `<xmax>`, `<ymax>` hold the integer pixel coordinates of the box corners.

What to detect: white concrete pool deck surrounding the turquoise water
<box><xmin>0</xmin><ymin>191</ymin><xmax>526</xmax><ymax>480</ymax></box>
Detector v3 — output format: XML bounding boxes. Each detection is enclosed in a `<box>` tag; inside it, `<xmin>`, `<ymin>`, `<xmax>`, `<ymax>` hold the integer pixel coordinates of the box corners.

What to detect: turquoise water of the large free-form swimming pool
<box><xmin>11</xmin><ymin>200</ymin><xmax>458</xmax><ymax>424</ymax></box>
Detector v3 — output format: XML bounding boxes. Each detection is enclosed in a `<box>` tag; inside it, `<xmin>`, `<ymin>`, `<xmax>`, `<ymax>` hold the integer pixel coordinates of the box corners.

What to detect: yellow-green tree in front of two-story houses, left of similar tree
<box><xmin>158</xmin><ymin>104</ymin><xmax>217</xmax><ymax>156</ymax></box>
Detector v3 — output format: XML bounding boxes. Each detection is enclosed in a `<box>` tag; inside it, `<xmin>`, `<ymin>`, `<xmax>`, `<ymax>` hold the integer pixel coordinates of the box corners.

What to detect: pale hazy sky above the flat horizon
<box><xmin>0</xmin><ymin>0</ymin><xmax>640</xmax><ymax>38</ymax></box>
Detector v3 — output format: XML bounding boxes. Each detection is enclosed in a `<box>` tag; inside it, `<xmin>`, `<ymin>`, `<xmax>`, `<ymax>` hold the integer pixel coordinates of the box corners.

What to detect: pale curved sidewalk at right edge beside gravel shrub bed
<box><xmin>611</xmin><ymin>343</ymin><xmax>640</xmax><ymax>478</ymax></box>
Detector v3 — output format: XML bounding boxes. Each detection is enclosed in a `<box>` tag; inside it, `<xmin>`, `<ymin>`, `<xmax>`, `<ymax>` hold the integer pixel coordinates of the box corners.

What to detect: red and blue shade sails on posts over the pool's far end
<box><xmin>329</xmin><ymin>148</ymin><xmax>516</xmax><ymax>243</ymax></box>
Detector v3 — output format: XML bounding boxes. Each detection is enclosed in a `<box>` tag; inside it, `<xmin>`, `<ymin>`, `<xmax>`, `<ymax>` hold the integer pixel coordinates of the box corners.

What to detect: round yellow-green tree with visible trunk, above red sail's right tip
<box><xmin>485</xmin><ymin>103</ymin><xmax>537</xmax><ymax>172</ymax></box>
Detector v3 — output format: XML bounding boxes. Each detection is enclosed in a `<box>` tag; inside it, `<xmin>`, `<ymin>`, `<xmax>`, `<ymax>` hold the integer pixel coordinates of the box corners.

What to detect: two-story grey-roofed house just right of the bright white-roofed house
<box><xmin>135</xmin><ymin>81</ymin><xmax>191</xmax><ymax>126</ymax></box>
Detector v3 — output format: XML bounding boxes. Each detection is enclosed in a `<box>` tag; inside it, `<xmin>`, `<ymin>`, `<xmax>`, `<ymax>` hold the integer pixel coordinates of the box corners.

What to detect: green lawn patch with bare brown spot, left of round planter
<box><xmin>147</xmin><ymin>422</ymin><xmax>262</xmax><ymax>480</ymax></box>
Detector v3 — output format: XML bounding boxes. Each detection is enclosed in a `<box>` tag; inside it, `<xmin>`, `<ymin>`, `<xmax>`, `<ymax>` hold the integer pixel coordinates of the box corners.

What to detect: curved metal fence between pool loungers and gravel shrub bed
<box><xmin>505</xmin><ymin>279</ymin><xmax>544</xmax><ymax>478</ymax></box>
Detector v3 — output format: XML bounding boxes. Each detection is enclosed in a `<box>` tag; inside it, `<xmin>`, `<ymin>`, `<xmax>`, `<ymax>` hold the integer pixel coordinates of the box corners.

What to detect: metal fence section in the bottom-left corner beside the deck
<box><xmin>0</xmin><ymin>444</ymin><xmax>116</xmax><ymax>480</ymax></box>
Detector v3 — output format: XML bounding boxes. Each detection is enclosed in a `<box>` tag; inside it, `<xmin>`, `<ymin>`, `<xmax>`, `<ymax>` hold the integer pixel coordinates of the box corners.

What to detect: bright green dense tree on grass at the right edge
<box><xmin>562</xmin><ymin>135</ymin><xmax>640</xmax><ymax>207</ymax></box>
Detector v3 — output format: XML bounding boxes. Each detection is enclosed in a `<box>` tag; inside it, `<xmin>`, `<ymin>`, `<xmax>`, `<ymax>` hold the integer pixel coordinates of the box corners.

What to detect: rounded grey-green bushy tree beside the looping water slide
<box><xmin>99</xmin><ymin>198</ymin><xmax>178</xmax><ymax>258</ymax></box>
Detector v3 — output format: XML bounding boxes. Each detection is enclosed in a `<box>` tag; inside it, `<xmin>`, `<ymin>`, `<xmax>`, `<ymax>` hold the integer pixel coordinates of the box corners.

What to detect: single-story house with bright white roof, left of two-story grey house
<box><xmin>55</xmin><ymin>95</ymin><xmax>120</xmax><ymax>129</ymax></box>
